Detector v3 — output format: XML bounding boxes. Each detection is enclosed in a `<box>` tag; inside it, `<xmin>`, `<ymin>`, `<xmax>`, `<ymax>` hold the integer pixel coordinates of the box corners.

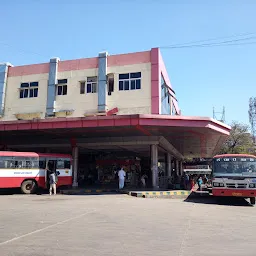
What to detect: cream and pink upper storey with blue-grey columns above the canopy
<box><xmin>0</xmin><ymin>48</ymin><xmax>180</xmax><ymax>121</ymax></box>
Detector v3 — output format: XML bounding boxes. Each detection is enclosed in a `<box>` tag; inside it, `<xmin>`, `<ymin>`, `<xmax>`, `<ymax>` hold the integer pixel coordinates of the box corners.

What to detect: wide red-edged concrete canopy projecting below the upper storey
<box><xmin>0</xmin><ymin>115</ymin><xmax>231</xmax><ymax>157</ymax></box>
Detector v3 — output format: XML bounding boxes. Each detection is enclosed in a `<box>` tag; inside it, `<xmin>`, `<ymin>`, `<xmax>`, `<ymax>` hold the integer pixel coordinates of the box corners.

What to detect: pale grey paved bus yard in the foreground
<box><xmin>0</xmin><ymin>195</ymin><xmax>256</xmax><ymax>256</ymax></box>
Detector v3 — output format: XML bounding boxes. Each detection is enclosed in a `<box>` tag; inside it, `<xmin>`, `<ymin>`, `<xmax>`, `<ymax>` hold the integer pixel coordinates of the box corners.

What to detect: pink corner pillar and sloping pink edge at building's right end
<box><xmin>151</xmin><ymin>48</ymin><xmax>181</xmax><ymax>114</ymax></box>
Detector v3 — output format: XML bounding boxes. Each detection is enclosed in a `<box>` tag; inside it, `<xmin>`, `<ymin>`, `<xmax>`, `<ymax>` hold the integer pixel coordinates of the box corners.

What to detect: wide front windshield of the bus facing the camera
<box><xmin>213</xmin><ymin>156</ymin><xmax>256</xmax><ymax>177</ymax></box>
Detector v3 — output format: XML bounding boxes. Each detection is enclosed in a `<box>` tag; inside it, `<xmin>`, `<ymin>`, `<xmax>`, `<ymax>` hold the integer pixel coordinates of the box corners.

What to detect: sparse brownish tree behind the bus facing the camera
<box><xmin>220</xmin><ymin>121</ymin><xmax>255</xmax><ymax>154</ymax></box>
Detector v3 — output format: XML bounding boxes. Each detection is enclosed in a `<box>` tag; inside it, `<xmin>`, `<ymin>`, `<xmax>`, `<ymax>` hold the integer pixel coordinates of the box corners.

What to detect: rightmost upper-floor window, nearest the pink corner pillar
<box><xmin>119</xmin><ymin>72</ymin><xmax>141</xmax><ymax>91</ymax></box>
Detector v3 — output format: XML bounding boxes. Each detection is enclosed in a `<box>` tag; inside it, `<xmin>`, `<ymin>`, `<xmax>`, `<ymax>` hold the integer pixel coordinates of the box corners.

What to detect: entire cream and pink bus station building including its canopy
<box><xmin>0</xmin><ymin>48</ymin><xmax>230</xmax><ymax>188</ymax></box>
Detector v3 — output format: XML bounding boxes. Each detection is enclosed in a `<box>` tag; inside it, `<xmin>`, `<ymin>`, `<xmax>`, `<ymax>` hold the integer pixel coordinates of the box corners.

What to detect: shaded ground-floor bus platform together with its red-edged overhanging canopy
<box><xmin>0</xmin><ymin>114</ymin><xmax>230</xmax><ymax>192</ymax></box>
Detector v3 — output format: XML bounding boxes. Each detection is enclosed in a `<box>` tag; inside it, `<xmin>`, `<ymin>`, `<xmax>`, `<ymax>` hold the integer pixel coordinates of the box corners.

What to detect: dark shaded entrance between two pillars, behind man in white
<box><xmin>78</xmin><ymin>155</ymin><xmax>151</xmax><ymax>189</ymax></box>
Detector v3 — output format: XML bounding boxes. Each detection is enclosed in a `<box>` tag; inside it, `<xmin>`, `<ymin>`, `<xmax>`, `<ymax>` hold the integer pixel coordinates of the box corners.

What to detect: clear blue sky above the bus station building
<box><xmin>0</xmin><ymin>0</ymin><xmax>256</xmax><ymax>126</ymax></box>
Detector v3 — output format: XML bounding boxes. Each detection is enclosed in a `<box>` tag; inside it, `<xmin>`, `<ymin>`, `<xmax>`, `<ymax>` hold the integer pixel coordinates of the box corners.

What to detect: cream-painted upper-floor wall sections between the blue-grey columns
<box><xmin>1</xmin><ymin>63</ymin><xmax>151</xmax><ymax>121</ymax></box>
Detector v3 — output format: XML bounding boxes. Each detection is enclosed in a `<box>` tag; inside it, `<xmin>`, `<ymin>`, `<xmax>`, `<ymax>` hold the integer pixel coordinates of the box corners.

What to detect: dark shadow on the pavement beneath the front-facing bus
<box><xmin>184</xmin><ymin>194</ymin><xmax>252</xmax><ymax>207</ymax></box>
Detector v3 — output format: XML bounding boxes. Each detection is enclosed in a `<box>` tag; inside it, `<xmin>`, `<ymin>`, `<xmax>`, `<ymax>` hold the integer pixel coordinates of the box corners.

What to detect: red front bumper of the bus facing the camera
<box><xmin>212</xmin><ymin>188</ymin><xmax>256</xmax><ymax>197</ymax></box>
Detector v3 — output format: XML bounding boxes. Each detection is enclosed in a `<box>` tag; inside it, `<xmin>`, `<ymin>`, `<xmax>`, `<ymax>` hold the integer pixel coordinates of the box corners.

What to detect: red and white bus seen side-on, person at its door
<box><xmin>0</xmin><ymin>151</ymin><xmax>72</xmax><ymax>194</ymax></box>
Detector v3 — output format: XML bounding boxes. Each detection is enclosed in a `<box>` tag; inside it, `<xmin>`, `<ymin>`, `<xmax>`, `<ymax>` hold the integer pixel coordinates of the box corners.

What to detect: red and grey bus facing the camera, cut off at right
<box><xmin>212</xmin><ymin>154</ymin><xmax>256</xmax><ymax>204</ymax></box>
